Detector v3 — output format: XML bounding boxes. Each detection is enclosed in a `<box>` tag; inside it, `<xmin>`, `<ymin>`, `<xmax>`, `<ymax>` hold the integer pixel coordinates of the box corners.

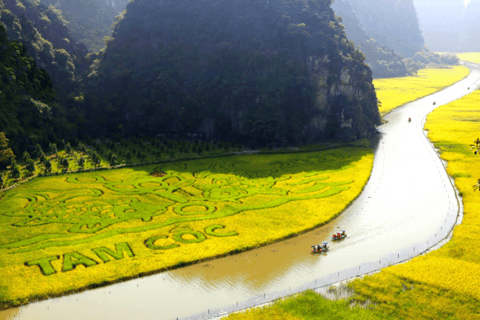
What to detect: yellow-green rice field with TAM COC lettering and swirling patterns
<box><xmin>0</xmin><ymin>147</ymin><xmax>373</xmax><ymax>308</ymax></box>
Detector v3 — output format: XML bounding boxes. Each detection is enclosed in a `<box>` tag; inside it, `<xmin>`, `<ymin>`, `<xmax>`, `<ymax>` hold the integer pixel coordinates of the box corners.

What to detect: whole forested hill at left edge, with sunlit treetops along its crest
<box><xmin>0</xmin><ymin>0</ymin><xmax>89</xmax><ymax>155</ymax></box>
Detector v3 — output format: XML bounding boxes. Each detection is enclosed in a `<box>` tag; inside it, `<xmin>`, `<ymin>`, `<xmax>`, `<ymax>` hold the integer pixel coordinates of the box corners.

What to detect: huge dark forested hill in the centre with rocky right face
<box><xmin>85</xmin><ymin>0</ymin><xmax>380</xmax><ymax>144</ymax></box>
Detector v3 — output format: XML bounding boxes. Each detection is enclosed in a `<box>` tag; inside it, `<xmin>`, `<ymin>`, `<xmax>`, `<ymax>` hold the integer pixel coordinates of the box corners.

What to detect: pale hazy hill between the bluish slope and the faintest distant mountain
<box><xmin>349</xmin><ymin>0</ymin><xmax>424</xmax><ymax>57</ymax></box>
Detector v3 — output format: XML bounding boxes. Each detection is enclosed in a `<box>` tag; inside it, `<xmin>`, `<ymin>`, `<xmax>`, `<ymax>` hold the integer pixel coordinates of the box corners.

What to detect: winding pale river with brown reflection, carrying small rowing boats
<box><xmin>0</xmin><ymin>62</ymin><xmax>480</xmax><ymax>320</ymax></box>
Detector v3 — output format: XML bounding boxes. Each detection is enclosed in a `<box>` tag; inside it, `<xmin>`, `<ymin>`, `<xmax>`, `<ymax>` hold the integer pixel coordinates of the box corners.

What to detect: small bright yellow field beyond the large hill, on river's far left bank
<box><xmin>373</xmin><ymin>66</ymin><xmax>470</xmax><ymax>116</ymax></box>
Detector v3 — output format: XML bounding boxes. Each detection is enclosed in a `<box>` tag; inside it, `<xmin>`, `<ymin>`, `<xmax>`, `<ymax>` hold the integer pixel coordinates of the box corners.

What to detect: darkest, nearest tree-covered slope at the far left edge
<box><xmin>0</xmin><ymin>24</ymin><xmax>58</xmax><ymax>155</ymax></box>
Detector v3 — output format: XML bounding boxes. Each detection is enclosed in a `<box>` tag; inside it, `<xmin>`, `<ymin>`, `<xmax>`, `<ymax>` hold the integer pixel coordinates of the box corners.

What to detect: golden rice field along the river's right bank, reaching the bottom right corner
<box><xmin>222</xmin><ymin>90</ymin><xmax>480</xmax><ymax>320</ymax></box>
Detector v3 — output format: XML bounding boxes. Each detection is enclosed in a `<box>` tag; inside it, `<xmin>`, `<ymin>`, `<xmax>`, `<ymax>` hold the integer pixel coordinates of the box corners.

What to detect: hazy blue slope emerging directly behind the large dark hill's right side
<box><xmin>332</xmin><ymin>0</ymin><xmax>408</xmax><ymax>78</ymax></box>
